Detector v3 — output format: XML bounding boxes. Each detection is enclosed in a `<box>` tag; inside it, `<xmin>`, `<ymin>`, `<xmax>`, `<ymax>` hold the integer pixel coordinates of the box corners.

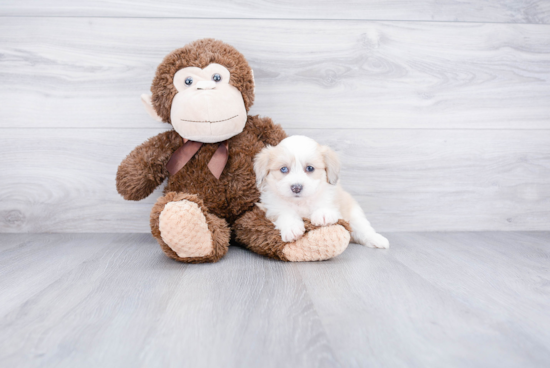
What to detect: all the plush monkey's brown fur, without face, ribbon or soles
<box><xmin>116</xmin><ymin>39</ymin><xmax>349</xmax><ymax>263</ymax></box>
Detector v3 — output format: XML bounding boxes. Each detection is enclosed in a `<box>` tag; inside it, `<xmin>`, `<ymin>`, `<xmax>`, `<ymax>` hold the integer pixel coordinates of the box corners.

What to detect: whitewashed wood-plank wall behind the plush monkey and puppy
<box><xmin>0</xmin><ymin>0</ymin><xmax>550</xmax><ymax>232</ymax></box>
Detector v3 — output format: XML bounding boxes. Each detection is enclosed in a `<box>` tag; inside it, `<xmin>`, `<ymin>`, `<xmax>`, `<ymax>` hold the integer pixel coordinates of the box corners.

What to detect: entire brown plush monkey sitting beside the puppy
<box><xmin>116</xmin><ymin>39</ymin><xmax>350</xmax><ymax>263</ymax></box>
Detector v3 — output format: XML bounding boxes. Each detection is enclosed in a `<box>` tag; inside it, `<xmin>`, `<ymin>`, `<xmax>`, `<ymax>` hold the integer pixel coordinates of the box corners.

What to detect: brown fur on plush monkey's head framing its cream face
<box><xmin>151</xmin><ymin>38</ymin><xmax>254</xmax><ymax>123</ymax></box>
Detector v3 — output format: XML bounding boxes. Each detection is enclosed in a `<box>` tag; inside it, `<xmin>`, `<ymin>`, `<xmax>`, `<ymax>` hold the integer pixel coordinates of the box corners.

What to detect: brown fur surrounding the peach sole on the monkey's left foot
<box><xmin>151</xmin><ymin>192</ymin><xmax>231</xmax><ymax>263</ymax></box>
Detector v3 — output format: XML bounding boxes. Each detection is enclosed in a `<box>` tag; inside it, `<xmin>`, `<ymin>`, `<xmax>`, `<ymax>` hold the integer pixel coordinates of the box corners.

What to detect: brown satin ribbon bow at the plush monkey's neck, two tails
<box><xmin>166</xmin><ymin>141</ymin><xmax>229</xmax><ymax>180</ymax></box>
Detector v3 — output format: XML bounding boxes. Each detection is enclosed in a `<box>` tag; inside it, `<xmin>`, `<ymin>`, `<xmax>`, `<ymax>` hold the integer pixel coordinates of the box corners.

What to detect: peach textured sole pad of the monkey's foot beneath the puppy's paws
<box><xmin>283</xmin><ymin>225</ymin><xmax>350</xmax><ymax>262</ymax></box>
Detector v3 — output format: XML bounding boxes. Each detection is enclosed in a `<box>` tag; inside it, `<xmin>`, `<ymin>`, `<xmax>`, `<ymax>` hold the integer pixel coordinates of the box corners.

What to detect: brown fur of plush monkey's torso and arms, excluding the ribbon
<box><xmin>117</xmin><ymin>116</ymin><xmax>286</xmax><ymax>220</ymax></box>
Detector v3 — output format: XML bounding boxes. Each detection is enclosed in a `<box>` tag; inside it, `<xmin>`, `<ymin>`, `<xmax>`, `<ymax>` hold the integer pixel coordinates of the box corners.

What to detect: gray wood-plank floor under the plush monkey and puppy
<box><xmin>0</xmin><ymin>232</ymin><xmax>550</xmax><ymax>367</ymax></box>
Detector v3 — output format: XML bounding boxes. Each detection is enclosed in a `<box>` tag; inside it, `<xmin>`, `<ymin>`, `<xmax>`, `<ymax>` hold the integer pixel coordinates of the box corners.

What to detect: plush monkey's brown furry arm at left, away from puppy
<box><xmin>116</xmin><ymin>130</ymin><xmax>181</xmax><ymax>201</ymax></box>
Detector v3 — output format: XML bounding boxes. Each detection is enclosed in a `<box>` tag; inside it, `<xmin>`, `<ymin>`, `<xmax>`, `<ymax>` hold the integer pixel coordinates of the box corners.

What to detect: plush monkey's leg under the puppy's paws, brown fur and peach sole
<box><xmin>233</xmin><ymin>206</ymin><xmax>351</xmax><ymax>262</ymax></box>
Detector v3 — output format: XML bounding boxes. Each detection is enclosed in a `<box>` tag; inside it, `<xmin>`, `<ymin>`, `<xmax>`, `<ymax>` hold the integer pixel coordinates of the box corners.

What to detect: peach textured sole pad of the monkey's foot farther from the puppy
<box><xmin>159</xmin><ymin>200</ymin><xmax>213</xmax><ymax>258</ymax></box>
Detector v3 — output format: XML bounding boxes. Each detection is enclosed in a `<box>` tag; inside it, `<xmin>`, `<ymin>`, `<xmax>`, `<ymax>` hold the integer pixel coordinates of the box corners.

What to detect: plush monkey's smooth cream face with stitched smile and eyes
<box><xmin>170</xmin><ymin>64</ymin><xmax>247</xmax><ymax>143</ymax></box>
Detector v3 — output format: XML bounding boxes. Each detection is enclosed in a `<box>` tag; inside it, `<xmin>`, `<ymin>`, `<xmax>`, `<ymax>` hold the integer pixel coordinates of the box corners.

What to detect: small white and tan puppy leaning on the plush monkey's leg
<box><xmin>254</xmin><ymin>135</ymin><xmax>390</xmax><ymax>248</ymax></box>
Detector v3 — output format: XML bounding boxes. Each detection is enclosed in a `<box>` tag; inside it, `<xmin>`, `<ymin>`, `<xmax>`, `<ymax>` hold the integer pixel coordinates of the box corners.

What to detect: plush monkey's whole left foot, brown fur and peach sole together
<box><xmin>151</xmin><ymin>192</ymin><xmax>229</xmax><ymax>263</ymax></box>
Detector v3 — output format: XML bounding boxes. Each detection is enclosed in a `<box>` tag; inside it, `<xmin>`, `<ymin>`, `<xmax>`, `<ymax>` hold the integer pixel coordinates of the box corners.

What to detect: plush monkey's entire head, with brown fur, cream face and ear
<box><xmin>147</xmin><ymin>38</ymin><xmax>254</xmax><ymax>139</ymax></box>
